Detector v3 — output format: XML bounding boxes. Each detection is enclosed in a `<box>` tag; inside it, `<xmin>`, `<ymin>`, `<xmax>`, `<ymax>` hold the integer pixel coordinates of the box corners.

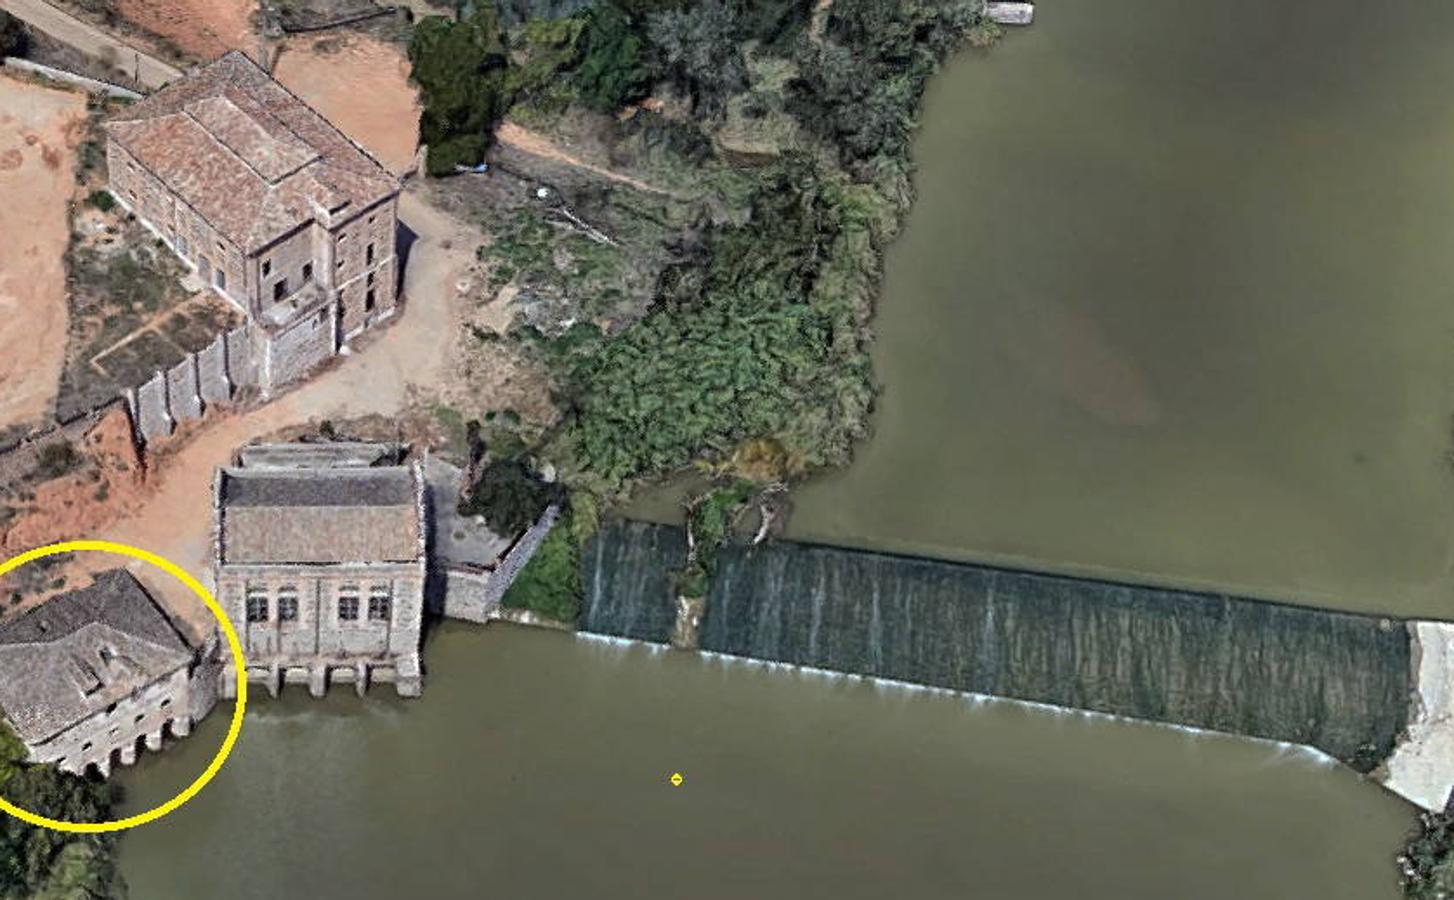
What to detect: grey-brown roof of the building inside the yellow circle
<box><xmin>0</xmin><ymin>568</ymin><xmax>192</xmax><ymax>744</ymax></box>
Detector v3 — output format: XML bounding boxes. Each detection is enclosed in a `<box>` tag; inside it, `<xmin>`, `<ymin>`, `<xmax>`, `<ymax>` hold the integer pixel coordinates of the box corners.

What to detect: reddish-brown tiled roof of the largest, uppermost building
<box><xmin>106</xmin><ymin>51</ymin><xmax>398</xmax><ymax>252</ymax></box>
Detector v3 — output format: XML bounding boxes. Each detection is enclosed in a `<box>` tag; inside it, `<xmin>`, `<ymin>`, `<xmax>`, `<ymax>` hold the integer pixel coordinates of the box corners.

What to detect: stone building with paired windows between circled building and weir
<box><xmin>214</xmin><ymin>445</ymin><xmax>426</xmax><ymax>696</ymax></box>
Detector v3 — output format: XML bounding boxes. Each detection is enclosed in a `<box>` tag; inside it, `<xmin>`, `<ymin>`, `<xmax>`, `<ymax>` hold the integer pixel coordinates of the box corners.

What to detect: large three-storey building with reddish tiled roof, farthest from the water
<box><xmin>106</xmin><ymin>51</ymin><xmax>400</xmax><ymax>393</ymax></box>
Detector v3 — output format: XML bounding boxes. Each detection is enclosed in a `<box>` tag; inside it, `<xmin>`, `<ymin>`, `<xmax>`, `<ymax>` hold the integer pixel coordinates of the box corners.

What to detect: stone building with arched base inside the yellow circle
<box><xmin>0</xmin><ymin>568</ymin><xmax>220</xmax><ymax>776</ymax></box>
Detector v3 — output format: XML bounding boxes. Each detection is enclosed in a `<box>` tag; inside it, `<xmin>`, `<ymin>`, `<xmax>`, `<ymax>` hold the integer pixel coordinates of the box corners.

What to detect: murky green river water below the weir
<box><xmin>122</xmin><ymin>625</ymin><xmax>1410</xmax><ymax>900</ymax></box>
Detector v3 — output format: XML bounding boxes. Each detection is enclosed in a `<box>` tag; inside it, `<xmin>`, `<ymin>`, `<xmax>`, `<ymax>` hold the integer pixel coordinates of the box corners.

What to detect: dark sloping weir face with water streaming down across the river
<box><xmin>583</xmin><ymin>522</ymin><xmax>1410</xmax><ymax>772</ymax></box>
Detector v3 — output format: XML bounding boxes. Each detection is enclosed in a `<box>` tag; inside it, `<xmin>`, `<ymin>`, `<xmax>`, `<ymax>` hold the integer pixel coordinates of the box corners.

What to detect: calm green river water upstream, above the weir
<box><xmin>640</xmin><ymin>0</ymin><xmax>1454</xmax><ymax>618</ymax></box>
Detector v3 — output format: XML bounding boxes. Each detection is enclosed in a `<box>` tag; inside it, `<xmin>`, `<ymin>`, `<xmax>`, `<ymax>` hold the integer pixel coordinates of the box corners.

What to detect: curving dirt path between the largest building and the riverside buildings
<box><xmin>95</xmin><ymin>187</ymin><xmax>480</xmax><ymax>624</ymax></box>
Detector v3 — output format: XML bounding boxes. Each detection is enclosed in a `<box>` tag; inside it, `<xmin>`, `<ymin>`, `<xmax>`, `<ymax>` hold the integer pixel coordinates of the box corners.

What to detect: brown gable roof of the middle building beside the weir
<box><xmin>218</xmin><ymin>465</ymin><xmax>423</xmax><ymax>564</ymax></box>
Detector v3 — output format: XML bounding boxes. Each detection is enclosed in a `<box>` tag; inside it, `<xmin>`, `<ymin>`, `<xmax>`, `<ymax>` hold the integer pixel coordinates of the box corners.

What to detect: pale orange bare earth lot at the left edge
<box><xmin>0</xmin><ymin>76</ymin><xmax>86</xmax><ymax>429</ymax></box>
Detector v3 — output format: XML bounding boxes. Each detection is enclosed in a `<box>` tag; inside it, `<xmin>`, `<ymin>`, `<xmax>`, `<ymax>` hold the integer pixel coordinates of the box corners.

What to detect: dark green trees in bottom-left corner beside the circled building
<box><xmin>0</xmin><ymin>723</ymin><xmax>126</xmax><ymax>900</ymax></box>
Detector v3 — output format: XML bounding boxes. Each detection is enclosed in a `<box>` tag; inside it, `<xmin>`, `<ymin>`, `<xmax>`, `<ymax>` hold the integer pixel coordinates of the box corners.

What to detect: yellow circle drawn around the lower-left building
<box><xmin>0</xmin><ymin>541</ymin><xmax>247</xmax><ymax>835</ymax></box>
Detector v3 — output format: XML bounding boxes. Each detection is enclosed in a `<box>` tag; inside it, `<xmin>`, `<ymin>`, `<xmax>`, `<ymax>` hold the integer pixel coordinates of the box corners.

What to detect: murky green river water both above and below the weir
<box><xmin>113</xmin><ymin>0</ymin><xmax>1454</xmax><ymax>900</ymax></box>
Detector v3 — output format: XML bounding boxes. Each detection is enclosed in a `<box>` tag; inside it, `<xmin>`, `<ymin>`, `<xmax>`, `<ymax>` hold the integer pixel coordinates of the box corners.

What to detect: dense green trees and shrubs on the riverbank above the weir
<box><xmin>421</xmin><ymin>0</ymin><xmax>996</xmax><ymax>608</ymax></box>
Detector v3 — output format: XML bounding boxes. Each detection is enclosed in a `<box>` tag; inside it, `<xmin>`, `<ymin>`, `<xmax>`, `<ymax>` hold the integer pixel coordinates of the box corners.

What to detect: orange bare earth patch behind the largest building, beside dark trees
<box><xmin>273</xmin><ymin>32</ymin><xmax>419</xmax><ymax>173</ymax></box>
